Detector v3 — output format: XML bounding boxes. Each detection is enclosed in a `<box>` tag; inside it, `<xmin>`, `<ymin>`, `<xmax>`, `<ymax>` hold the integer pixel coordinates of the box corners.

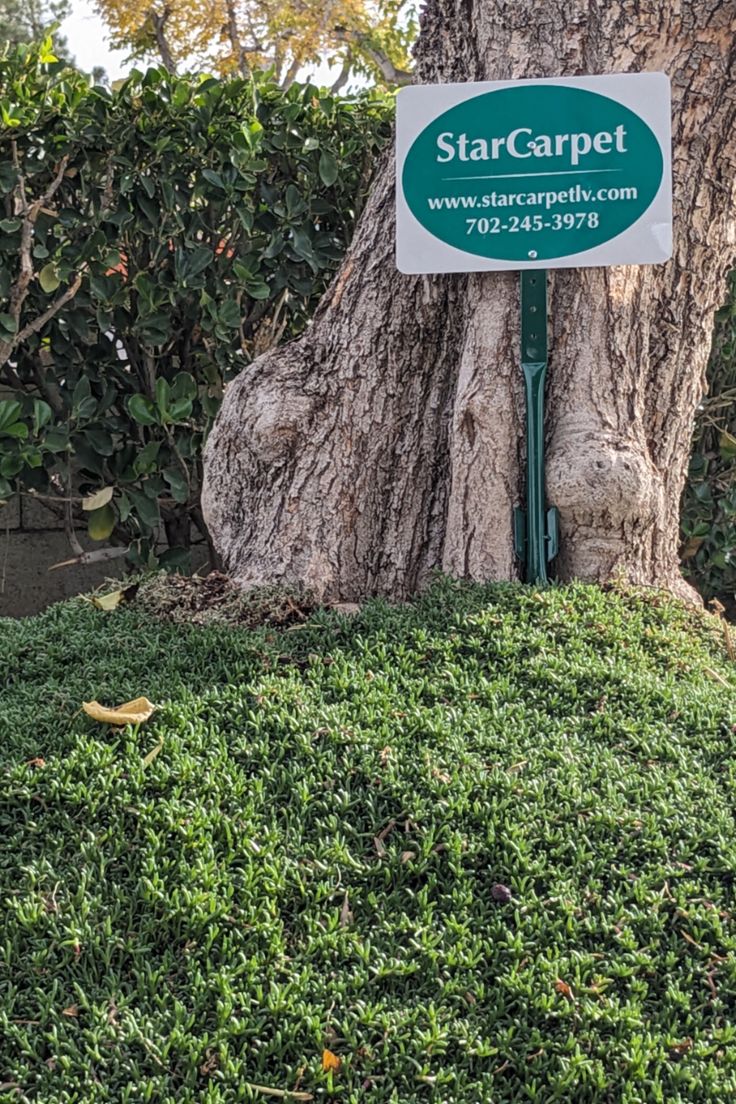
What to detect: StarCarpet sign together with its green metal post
<box><xmin>396</xmin><ymin>73</ymin><xmax>672</xmax><ymax>583</ymax></box>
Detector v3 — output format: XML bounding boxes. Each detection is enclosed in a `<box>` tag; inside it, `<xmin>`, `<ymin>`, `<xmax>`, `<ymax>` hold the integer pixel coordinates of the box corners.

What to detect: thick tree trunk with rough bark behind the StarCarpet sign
<box><xmin>203</xmin><ymin>0</ymin><xmax>736</xmax><ymax>601</ymax></box>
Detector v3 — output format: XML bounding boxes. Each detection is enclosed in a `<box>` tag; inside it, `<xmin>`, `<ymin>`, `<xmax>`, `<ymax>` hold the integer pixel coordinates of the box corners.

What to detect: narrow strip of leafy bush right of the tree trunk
<box><xmin>682</xmin><ymin>273</ymin><xmax>736</xmax><ymax>606</ymax></box>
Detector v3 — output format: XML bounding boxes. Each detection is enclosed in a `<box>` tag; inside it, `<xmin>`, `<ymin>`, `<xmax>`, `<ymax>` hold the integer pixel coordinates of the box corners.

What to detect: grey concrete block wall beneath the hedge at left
<box><xmin>0</xmin><ymin>495</ymin><xmax>124</xmax><ymax>617</ymax></box>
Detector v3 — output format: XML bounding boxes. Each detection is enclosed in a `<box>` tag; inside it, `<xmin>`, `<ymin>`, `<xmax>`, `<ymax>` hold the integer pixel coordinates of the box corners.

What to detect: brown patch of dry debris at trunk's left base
<box><xmin>134</xmin><ymin>571</ymin><xmax>316</xmax><ymax>628</ymax></box>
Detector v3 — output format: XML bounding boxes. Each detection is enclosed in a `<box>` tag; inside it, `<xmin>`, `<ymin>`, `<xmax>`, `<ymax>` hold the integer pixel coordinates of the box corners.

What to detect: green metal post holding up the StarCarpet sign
<box><xmin>514</xmin><ymin>269</ymin><xmax>559</xmax><ymax>584</ymax></box>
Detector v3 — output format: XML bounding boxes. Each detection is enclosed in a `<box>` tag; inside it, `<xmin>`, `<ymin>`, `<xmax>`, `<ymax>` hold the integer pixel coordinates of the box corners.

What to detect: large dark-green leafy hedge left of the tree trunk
<box><xmin>0</xmin><ymin>42</ymin><xmax>388</xmax><ymax>565</ymax></box>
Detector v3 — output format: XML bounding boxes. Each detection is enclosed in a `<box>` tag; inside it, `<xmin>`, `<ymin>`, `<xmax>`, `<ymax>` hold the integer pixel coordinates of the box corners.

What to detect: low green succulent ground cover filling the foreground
<box><xmin>0</xmin><ymin>582</ymin><xmax>736</xmax><ymax>1104</ymax></box>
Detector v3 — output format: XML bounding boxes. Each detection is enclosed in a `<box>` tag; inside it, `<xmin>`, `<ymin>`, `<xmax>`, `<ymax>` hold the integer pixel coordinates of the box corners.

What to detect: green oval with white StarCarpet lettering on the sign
<box><xmin>402</xmin><ymin>84</ymin><xmax>663</xmax><ymax>261</ymax></box>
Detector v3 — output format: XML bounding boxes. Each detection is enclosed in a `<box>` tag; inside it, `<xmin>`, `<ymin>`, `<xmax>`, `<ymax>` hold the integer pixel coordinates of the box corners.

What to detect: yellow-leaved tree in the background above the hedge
<box><xmin>97</xmin><ymin>0</ymin><xmax>416</xmax><ymax>91</ymax></box>
